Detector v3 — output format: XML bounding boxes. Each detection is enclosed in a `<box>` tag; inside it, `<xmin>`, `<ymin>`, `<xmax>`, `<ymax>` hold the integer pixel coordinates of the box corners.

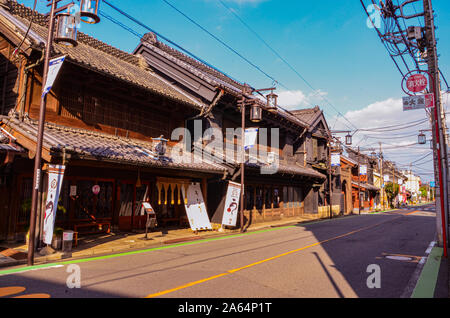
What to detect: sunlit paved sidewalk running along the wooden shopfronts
<box><xmin>0</xmin><ymin>216</ymin><xmax>330</xmax><ymax>268</ymax></box>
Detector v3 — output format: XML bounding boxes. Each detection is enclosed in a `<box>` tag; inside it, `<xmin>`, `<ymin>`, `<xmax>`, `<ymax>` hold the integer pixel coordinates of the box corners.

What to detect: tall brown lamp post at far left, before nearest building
<box><xmin>27</xmin><ymin>0</ymin><xmax>99</xmax><ymax>266</ymax></box>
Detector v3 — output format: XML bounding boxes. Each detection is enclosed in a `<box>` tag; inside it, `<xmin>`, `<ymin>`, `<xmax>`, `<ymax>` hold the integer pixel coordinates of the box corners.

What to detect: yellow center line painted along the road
<box><xmin>145</xmin><ymin>216</ymin><xmax>400</xmax><ymax>298</ymax></box>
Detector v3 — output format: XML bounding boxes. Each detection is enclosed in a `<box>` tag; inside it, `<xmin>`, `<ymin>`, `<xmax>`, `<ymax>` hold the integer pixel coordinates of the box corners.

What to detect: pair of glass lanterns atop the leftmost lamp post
<box><xmin>55</xmin><ymin>0</ymin><xmax>101</xmax><ymax>47</ymax></box>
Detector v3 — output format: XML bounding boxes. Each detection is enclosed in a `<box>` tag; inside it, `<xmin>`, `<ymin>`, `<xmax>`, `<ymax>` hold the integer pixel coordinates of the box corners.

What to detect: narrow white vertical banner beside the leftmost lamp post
<box><xmin>42</xmin><ymin>165</ymin><xmax>66</xmax><ymax>245</ymax></box>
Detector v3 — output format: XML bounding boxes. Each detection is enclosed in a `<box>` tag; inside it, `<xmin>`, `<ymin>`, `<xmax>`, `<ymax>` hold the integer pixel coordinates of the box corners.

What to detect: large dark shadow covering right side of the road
<box><xmin>290</xmin><ymin>211</ymin><xmax>438</xmax><ymax>298</ymax></box>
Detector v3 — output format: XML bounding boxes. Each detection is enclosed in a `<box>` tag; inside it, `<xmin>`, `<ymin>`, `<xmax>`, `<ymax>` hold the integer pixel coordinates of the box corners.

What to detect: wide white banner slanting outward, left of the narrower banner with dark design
<box><xmin>181</xmin><ymin>183</ymin><xmax>212</xmax><ymax>231</ymax></box>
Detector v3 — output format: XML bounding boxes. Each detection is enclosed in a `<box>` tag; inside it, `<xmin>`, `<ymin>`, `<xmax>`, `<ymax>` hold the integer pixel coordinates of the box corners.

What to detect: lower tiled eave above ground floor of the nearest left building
<box><xmin>3</xmin><ymin>117</ymin><xmax>227</xmax><ymax>174</ymax></box>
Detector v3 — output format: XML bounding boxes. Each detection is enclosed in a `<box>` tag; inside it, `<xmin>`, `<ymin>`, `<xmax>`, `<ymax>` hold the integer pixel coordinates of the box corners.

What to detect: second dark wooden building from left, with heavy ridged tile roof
<box><xmin>134</xmin><ymin>33</ymin><xmax>326</xmax><ymax>224</ymax></box>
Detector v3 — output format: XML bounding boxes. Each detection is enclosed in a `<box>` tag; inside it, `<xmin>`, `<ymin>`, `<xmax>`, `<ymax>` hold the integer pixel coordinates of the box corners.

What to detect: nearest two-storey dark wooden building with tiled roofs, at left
<box><xmin>0</xmin><ymin>1</ymin><xmax>232</xmax><ymax>240</ymax></box>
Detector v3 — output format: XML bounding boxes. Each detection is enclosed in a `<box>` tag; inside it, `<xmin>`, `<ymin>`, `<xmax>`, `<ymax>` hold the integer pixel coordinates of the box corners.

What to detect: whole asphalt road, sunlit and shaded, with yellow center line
<box><xmin>0</xmin><ymin>205</ymin><xmax>436</xmax><ymax>298</ymax></box>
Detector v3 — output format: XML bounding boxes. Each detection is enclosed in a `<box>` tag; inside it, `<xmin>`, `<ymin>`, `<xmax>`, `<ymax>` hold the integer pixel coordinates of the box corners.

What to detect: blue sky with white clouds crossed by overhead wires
<box><xmin>18</xmin><ymin>0</ymin><xmax>450</xmax><ymax>181</ymax></box>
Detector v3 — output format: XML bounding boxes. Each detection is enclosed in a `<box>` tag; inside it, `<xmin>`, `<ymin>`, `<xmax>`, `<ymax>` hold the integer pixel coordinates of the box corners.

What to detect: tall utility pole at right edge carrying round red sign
<box><xmin>423</xmin><ymin>0</ymin><xmax>448</xmax><ymax>258</ymax></box>
